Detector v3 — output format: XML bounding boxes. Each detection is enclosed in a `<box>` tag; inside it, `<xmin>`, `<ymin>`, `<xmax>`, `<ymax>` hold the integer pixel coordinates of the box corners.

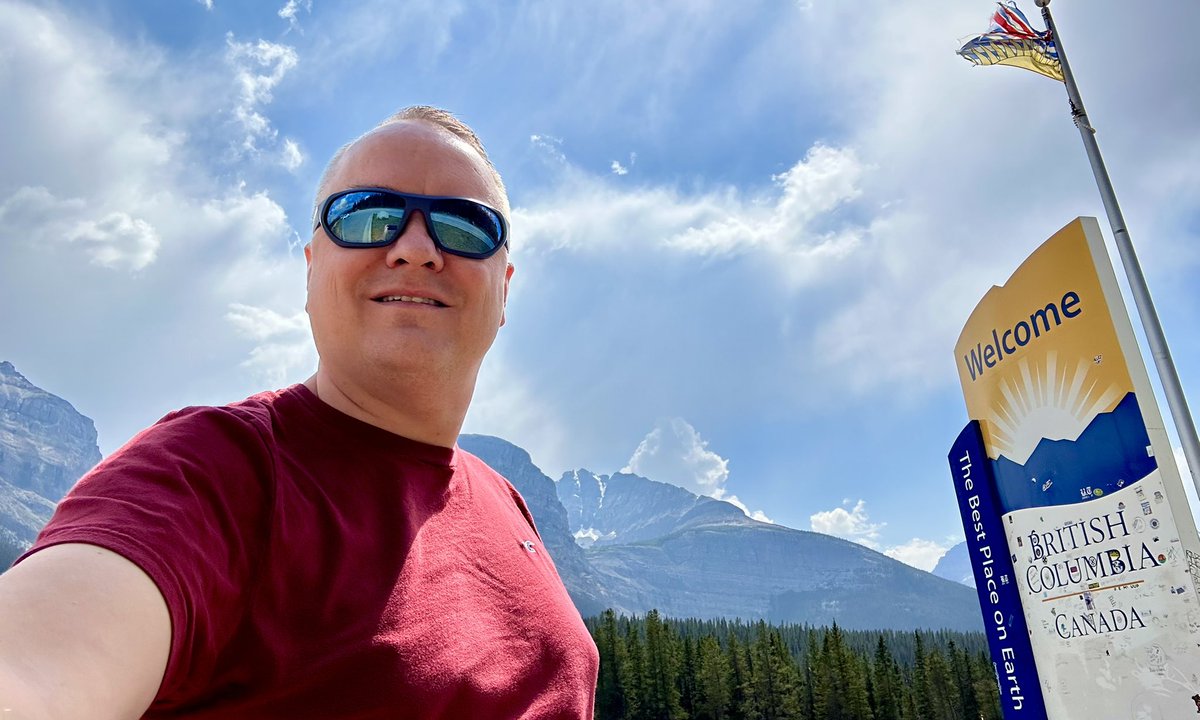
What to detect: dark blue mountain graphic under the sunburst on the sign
<box><xmin>991</xmin><ymin>392</ymin><xmax>1158</xmax><ymax>512</ymax></box>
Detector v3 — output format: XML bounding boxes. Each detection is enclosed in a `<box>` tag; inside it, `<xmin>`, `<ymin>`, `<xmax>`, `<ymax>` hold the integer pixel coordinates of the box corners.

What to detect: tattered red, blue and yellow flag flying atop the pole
<box><xmin>959</xmin><ymin>0</ymin><xmax>1063</xmax><ymax>82</ymax></box>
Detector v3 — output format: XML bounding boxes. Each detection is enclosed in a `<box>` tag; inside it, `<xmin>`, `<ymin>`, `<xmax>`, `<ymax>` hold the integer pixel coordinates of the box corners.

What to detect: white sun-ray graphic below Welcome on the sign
<box><xmin>989</xmin><ymin>352</ymin><xmax>1124</xmax><ymax>464</ymax></box>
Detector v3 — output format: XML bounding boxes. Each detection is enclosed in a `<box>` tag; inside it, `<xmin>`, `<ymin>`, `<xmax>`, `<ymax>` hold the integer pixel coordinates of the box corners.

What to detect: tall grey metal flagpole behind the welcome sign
<box><xmin>1034</xmin><ymin>0</ymin><xmax>1200</xmax><ymax>494</ymax></box>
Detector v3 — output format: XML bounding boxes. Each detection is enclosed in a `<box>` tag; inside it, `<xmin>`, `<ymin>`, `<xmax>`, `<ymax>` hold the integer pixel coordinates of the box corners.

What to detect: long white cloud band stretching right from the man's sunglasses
<box><xmin>514</xmin><ymin>142</ymin><xmax>869</xmax><ymax>284</ymax></box>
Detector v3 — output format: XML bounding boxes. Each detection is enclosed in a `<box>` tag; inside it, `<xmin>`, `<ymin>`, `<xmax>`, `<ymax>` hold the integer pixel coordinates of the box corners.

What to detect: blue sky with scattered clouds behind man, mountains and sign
<box><xmin>0</xmin><ymin>0</ymin><xmax>1200</xmax><ymax>568</ymax></box>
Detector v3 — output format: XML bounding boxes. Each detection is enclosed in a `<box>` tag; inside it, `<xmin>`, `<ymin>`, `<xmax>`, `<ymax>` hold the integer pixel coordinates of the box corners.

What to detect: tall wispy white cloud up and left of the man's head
<box><xmin>226</xmin><ymin>32</ymin><xmax>300</xmax><ymax>162</ymax></box>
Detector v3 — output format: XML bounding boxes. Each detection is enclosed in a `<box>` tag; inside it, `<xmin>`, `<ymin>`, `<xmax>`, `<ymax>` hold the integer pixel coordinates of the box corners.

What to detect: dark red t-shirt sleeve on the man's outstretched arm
<box><xmin>18</xmin><ymin>408</ymin><xmax>274</xmax><ymax>703</ymax></box>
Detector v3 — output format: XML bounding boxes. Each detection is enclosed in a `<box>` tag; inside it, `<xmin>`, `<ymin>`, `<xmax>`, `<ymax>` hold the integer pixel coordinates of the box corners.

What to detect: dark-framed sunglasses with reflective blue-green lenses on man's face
<box><xmin>312</xmin><ymin>187</ymin><xmax>509</xmax><ymax>259</ymax></box>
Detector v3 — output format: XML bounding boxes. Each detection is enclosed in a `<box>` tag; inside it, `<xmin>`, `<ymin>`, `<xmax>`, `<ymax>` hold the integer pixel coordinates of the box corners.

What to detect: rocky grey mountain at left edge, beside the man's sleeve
<box><xmin>0</xmin><ymin>361</ymin><xmax>101</xmax><ymax>570</ymax></box>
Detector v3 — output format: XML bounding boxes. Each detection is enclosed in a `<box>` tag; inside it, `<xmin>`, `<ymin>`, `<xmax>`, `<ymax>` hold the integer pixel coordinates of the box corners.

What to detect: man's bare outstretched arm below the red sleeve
<box><xmin>0</xmin><ymin>544</ymin><xmax>170</xmax><ymax>720</ymax></box>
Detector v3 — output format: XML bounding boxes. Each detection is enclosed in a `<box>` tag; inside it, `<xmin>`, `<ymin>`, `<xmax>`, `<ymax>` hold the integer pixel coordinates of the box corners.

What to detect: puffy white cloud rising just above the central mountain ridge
<box><xmin>622</xmin><ymin>418</ymin><xmax>772</xmax><ymax>522</ymax></box>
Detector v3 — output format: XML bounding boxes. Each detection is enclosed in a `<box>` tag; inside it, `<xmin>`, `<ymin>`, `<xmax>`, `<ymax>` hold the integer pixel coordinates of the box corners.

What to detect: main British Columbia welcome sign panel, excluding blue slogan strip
<box><xmin>955</xmin><ymin>217</ymin><xmax>1200</xmax><ymax>720</ymax></box>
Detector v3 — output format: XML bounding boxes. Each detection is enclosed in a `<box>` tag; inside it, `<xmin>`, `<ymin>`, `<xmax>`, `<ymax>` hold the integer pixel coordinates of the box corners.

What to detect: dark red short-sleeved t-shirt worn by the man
<box><xmin>19</xmin><ymin>385</ymin><xmax>599</xmax><ymax>720</ymax></box>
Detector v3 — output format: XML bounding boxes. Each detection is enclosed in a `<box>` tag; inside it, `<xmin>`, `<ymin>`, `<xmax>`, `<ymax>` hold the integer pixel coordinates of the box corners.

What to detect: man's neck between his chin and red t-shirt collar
<box><xmin>304</xmin><ymin>366</ymin><xmax>474</xmax><ymax>448</ymax></box>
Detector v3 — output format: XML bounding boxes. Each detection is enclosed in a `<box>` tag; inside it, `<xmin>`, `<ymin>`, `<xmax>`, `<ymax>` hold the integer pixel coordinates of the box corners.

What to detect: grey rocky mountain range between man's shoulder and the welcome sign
<box><xmin>470</xmin><ymin>436</ymin><xmax>983</xmax><ymax>630</ymax></box>
